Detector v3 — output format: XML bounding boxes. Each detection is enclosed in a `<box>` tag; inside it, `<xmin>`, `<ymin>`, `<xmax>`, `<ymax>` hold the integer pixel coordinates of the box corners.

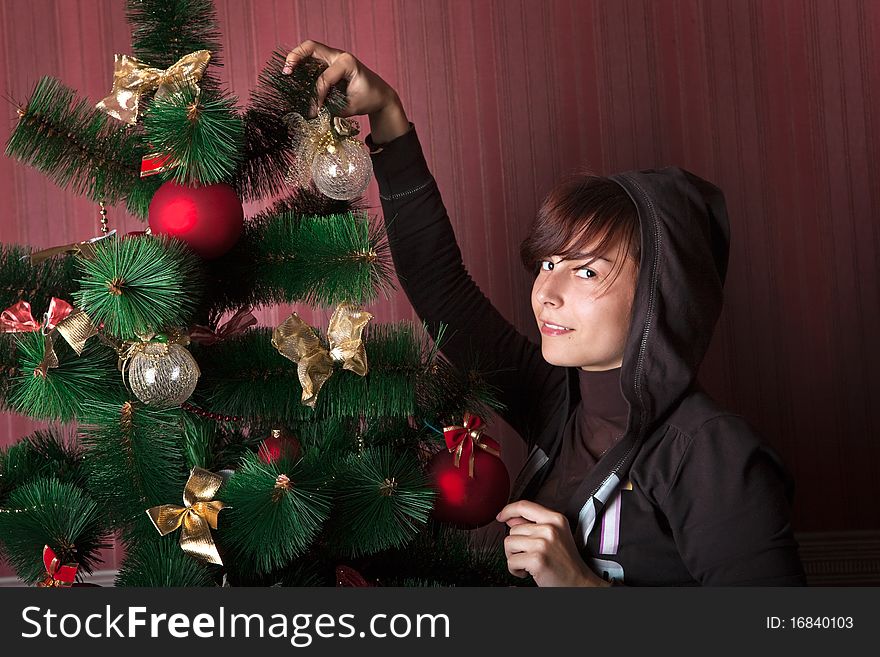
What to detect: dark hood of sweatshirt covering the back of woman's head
<box><xmin>534</xmin><ymin>167</ymin><xmax>730</xmax><ymax>510</ymax></box>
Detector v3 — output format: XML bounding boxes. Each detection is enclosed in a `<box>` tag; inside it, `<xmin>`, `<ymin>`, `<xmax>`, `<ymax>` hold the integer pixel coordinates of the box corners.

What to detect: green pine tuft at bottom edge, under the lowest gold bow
<box><xmin>116</xmin><ymin>530</ymin><xmax>216</xmax><ymax>588</ymax></box>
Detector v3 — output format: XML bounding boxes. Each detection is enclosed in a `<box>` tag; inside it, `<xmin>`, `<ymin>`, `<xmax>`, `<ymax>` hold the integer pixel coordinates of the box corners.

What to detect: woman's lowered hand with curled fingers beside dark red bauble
<box><xmin>496</xmin><ymin>500</ymin><xmax>610</xmax><ymax>586</ymax></box>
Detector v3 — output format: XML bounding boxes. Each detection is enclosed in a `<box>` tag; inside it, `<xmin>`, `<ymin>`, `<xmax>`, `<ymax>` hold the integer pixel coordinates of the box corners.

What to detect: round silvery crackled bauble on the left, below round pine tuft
<box><xmin>125</xmin><ymin>342</ymin><xmax>201</xmax><ymax>408</ymax></box>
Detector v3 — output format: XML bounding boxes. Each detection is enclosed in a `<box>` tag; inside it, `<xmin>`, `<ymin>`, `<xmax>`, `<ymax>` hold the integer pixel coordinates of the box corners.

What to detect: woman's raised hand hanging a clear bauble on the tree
<box><xmin>283</xmin><ymin>40</ymin><xmax>409</xmax><ymax>144</ymax></box>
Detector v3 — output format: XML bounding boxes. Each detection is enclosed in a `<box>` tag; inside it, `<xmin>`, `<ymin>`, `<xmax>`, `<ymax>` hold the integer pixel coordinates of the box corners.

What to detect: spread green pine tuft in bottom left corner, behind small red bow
<box><xmin>0</xmin><ymin>478</ymin><xmax>110</xmax><ymax>584</ymax></box>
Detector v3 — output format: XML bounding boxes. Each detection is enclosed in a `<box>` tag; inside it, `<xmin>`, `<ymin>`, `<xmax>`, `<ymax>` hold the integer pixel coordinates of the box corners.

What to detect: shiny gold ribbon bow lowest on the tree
<box><xmin>147</xmin><ymin>468</ymin><xmax>232</xmax><ymax>566</ymax></box>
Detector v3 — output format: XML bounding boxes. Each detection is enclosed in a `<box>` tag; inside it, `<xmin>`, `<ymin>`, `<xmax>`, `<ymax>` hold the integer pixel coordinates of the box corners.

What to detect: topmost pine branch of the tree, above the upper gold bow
<box><xmin>126</xmin><ymin>0</ymin><xmax>221</xmax><ymax>69</ymax></box>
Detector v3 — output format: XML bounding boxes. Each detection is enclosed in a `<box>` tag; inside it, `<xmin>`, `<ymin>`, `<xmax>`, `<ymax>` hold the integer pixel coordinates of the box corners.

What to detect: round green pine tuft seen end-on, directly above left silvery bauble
<box><xmin>77</xmin><ymin>235</ymin><xmax>204</xmax><ymax>340</ymax></box>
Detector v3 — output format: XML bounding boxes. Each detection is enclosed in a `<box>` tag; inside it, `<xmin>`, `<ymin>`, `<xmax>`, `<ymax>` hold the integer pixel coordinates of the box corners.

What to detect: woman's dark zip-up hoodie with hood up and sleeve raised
<box><xmin>367</xmin><ymin>128</ymin><xmax>805</xmax><ymax>586</ymax></box>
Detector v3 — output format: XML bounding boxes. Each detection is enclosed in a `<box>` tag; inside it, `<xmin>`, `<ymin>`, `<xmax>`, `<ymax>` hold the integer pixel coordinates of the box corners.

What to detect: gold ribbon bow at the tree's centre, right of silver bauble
<box><xmin>272</xmin><ymin>303</ymin><xmax>373</xmax><ymax>408</ymax></box>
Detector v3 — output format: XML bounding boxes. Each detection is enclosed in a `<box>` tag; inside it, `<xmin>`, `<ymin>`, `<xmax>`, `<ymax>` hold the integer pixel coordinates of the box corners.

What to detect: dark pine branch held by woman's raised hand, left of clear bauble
<box><xmin>237</xmin><ymin>49</ymin><xmax>347</xmax><ymax>200</ymax></box>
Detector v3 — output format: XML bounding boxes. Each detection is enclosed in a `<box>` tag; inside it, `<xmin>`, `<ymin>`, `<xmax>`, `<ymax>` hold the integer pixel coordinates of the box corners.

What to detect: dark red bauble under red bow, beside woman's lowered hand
<box><xmin>428</xmin><ymin>437</ymin><xmax>510</xmax><ymax>529</ymax></box>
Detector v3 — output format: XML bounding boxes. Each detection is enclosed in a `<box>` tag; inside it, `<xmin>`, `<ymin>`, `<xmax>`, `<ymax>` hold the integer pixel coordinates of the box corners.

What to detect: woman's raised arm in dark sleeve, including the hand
<box><xmin>285</xmin><ymin>41</ymin><xmax>567</xmax><ymax>442</ymax></box>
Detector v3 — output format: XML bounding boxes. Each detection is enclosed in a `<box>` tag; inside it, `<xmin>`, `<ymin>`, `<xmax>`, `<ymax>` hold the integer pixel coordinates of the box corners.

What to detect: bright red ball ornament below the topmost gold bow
<box><xmin>149</xmin><ymin>181</ymin><xmax>244</xmax><ymax>259</ymax></box>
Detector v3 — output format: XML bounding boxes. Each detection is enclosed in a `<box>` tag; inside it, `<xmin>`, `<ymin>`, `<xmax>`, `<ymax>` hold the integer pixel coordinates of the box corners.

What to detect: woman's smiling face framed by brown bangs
<box><xmin>532</xmin><ymin>243</ymin><xmax>638</xmax><ymax>371</ymax></box>
